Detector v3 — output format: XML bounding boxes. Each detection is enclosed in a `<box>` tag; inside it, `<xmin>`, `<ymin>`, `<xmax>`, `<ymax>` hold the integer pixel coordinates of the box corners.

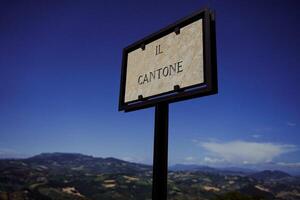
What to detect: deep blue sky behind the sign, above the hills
<box><xmin>0</xmin><ymin>0</ymin><xmax>300</xmax><ymax>172</ymax></box>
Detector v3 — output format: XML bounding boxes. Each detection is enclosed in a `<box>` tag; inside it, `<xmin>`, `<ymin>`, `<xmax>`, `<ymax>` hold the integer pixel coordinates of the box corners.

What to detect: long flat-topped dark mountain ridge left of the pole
<box><xmin>0</xmin><ymin>153</ymin><xmax>152</xmax><ymax>173</ymax></box>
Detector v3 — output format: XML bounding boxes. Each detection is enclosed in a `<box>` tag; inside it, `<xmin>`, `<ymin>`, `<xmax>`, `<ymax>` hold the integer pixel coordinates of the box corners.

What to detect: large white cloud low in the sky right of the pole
<box><xmin>199</xmin><ymin>141</ymin><xmax>297</xmax><ymax>164</ymax></box>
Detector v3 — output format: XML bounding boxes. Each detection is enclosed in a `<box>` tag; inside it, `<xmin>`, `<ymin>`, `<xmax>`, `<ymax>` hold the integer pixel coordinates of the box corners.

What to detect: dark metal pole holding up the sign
<box><xmin>152</xmin><ymin>103</ymin><xmax>169</xmax><ymax>200</ymax></box>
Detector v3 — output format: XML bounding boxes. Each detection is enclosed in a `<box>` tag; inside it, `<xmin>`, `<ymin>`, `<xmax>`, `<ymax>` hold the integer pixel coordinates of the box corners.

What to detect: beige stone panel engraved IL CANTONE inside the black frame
<box><xmin>125</xmin><ymin>19</ymin><xmax>204</xmax><ymax>103</ymax></box>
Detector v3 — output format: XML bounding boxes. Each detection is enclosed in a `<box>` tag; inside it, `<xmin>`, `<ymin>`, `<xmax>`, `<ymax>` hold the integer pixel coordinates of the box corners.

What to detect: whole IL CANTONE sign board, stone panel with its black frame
<box><xmin>119</xmin><ymin>10</ymin><xmax>217</xmax><ymax>111</ymax></box>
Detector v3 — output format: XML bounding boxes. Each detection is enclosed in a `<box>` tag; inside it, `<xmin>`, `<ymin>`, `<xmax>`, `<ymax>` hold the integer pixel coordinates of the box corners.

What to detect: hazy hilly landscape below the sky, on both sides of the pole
<box><xmin>0</xmin><ymin>153</ymin><xmax>300</xmax><ymax>200</ymax></box>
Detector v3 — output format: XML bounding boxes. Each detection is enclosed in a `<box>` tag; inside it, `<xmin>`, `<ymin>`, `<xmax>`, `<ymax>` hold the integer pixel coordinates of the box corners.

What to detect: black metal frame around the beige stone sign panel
<box><xmin>119</xmin><ymin>9</ymin><xmax>218</xmax><ymax>112</ymax></box>
